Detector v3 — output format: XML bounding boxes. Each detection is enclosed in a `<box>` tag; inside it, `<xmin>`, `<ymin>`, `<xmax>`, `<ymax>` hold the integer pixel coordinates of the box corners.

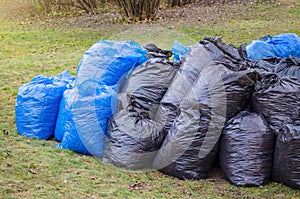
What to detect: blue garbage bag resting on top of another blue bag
<box><xmin>76</xmin><ymin>40</ymin><xmax>147</xmax><ymax>86</ymax></box>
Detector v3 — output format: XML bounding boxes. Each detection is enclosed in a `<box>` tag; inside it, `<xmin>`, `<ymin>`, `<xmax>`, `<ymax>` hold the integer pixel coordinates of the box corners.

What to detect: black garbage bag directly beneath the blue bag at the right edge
<box><xmin>254</xmin><ymin>57</ymin><xmax>300</xmax><ymax>81</ymax></box>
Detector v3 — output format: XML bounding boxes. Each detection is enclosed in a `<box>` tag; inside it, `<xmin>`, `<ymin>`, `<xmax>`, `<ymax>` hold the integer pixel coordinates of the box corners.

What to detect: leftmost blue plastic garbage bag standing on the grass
<box><xmin>15</xmin><ymin>71</ymin><xmax>74</xmax><ymax>139</ymax></box>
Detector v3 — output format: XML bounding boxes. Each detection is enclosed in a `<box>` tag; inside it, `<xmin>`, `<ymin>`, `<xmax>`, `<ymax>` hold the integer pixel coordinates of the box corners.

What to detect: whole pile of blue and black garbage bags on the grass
<box><xmin>15</xmin><ymin>34</ymin><xmax>300</xmax><ymax>189</ymax></box>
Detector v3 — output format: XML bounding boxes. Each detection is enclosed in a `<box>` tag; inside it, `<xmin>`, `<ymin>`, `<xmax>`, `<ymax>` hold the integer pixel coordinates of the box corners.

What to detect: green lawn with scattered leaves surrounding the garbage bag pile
<box><xmin>0</xmin><ymin>0</ymin><xmax>300</xmax><ymax>199</ymax></box>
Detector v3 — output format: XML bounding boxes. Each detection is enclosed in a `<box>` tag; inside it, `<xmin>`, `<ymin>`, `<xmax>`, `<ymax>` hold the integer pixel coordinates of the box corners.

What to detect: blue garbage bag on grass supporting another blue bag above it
<box><xmin>56</xmin><ymin>81</ymin><xmax>118</xmax><ymax>157</ymax></box>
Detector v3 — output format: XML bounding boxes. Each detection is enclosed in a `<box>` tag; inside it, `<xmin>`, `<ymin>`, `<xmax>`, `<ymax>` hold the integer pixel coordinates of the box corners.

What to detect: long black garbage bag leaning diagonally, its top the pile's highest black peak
<box><xmin>157</xmin><ymin>37</ymin><xmax>253</xmax><ymax>135</ymax></box>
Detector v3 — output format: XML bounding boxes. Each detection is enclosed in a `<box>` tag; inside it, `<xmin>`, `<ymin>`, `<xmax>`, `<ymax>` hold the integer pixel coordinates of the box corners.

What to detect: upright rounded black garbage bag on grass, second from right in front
<box><xmin>220</xmin><ymin>111</ymin><xmax>275</xmax><ymax>186</ymax></box>
